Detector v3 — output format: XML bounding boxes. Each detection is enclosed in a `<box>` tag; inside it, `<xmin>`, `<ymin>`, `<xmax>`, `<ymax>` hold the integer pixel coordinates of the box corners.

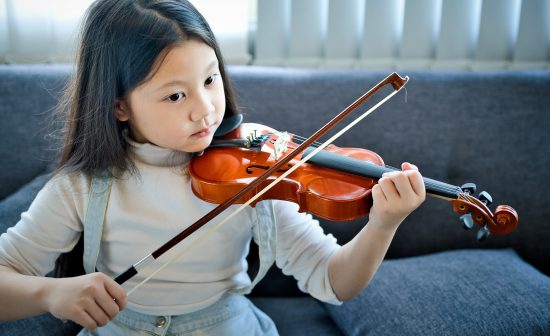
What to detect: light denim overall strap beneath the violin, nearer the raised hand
<box><xmin>230</xmin><ymin>201</ymin><xmax>277</xmax><ymax>294</ymax></box>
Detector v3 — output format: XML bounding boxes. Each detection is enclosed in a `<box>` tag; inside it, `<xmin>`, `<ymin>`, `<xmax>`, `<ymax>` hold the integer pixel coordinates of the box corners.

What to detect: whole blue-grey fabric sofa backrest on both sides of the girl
<box><xmin>0</xmin><ymin>65</ymin><xmax>550</xmax><ymax>288</ymax></box>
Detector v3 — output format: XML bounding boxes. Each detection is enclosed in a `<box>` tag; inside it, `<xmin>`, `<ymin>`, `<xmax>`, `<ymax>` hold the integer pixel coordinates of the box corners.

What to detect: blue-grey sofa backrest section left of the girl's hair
<box><xmin>0</xmin><ymin>65</ymin><xmax>71</xmax><ymax>200</ymax></box>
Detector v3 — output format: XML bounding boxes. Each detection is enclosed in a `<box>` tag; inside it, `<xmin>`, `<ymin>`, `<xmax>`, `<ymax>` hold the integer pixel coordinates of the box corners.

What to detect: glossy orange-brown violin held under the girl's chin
<box><xmin>189</xmin><ymin>123</ymin><xmax>518</xmax><ymax>240</ymax></box>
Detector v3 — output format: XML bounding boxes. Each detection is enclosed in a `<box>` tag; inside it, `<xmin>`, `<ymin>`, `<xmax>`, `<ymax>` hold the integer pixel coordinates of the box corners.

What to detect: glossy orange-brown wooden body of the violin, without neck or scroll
<box><xmin>189</xmin><ymin>123</ymin><xmax>384</xmax><ymax>221</ymax></box>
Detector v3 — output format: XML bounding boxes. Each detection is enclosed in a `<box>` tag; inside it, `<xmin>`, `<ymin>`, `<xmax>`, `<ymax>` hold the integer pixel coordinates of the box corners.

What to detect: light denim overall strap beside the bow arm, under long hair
<box><xmin>83</xmin><ymin>173</ymin><xmax>111</xmax><ymax>274</ymax></box>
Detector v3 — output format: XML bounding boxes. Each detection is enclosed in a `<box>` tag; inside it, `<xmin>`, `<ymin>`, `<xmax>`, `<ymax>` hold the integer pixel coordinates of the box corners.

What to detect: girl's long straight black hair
<box><xmin>56</xmin><ymin>0</ymin><xmax>242</xmax><ymax>276</ymax></box>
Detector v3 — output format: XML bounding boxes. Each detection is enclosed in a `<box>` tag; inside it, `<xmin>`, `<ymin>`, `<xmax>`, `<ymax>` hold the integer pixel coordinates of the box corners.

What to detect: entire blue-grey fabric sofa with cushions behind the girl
<box><xmin>0</xmin><ymin>65</ymin><xmax>550</xmax><ymax>336</ymax></box>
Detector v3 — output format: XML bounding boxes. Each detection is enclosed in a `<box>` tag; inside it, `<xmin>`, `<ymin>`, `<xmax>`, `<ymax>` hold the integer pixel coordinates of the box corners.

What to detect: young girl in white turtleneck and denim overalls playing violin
<box><xmin>0</xmin><ymin>0</ymin><xmax>425</xmax><ymax>335</ymax></box>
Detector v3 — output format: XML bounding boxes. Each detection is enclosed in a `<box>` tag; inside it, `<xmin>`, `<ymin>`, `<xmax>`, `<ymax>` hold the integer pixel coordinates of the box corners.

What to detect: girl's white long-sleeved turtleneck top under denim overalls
<box><xmin>0</xmin><ymin>140</ymin><xmax>340</xmax><ymax>315</ymax></box>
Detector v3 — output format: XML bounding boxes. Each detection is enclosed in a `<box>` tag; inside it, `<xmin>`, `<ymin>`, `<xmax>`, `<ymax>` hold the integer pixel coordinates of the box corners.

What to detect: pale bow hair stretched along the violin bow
<box><xmin>127</xmin><ymin>84</ymin><xmax>408</xmax><ymax>296</ymax></box>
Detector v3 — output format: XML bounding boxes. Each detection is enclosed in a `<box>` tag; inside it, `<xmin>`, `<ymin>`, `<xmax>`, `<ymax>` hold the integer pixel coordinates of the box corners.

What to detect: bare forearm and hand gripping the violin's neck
<box><xmin>328</xmin><ymin>163</ymin><xmax>426</xmax><ymax>301</ymax></box>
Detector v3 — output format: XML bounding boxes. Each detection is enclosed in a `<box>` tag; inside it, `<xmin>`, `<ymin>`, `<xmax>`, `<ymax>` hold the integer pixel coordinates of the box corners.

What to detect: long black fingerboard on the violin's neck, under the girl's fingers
<box><xmin>303</xmin><ymin>147</ymin><xmax>462</xmax><ymax>199</ymax></box>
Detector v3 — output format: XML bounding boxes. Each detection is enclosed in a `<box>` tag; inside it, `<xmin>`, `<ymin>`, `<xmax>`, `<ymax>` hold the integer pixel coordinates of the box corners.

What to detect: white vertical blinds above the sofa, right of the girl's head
<box><xmin>254</xmin><ymin>0</ymin><xmax>550</xmax><ymax>70</ymax></box>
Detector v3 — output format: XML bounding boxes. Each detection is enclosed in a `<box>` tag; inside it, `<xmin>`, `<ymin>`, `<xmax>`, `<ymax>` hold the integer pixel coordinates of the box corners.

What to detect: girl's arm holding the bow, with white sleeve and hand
<box><xmin>0</xmin><ymin>178</ymin><xmax>126</xmax><ymax>329</ymax></box>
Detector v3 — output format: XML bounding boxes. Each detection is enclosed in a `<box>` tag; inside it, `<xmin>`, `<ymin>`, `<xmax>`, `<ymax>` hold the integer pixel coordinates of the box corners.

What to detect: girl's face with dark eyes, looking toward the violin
<box><xmin>115</xmin><ymin>40</ymin><xmax>225</xmax><ymax>152</ymax></box>
